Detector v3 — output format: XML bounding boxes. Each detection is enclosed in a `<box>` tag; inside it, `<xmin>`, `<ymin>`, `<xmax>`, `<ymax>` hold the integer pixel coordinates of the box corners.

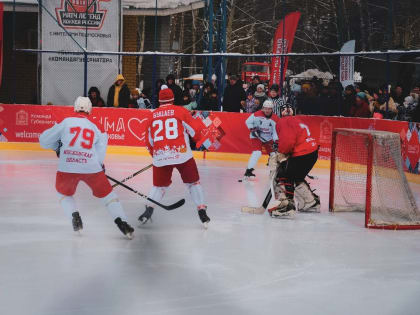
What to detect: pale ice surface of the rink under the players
<box><xmin>0</xmin><ymin>150</ymin><xmax>420</xmax><ymax>315</ymax></box>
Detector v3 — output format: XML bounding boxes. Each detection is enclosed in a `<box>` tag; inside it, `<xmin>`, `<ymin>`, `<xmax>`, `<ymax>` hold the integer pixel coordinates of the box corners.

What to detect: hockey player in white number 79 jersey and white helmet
<box><xmin>39</xmin><ymin>96</ymin><xmax>134</xmax><ymax>239</ymax></box>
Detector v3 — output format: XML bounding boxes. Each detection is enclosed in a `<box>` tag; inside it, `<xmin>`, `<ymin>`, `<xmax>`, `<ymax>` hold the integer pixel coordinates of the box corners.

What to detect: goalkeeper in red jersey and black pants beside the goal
<box><xmin>268</xmin><ymin>116</ymin><xmax>320</xmax><ymax>217</ymax></box>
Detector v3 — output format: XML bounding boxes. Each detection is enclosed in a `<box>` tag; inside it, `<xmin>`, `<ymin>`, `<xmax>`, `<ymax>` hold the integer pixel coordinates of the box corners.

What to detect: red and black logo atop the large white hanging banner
<box><xmin>55</xmin><ymin>0</ymin><xmax>111</xmax><ymax>30</ymax></box>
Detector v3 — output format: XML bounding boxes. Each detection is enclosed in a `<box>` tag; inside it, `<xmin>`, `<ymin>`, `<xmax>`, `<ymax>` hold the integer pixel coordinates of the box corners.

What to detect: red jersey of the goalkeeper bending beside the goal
<box><xmin>276</xmin><ymin>116</ymin><xmax>318</xmax><ymax>157</ymax></box>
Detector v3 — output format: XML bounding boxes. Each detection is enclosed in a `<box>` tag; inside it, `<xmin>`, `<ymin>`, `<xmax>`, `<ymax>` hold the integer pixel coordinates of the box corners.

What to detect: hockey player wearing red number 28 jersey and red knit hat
<box><xmin>139</xmin><ymin>86</ymin><xmax>210</xmax><ymax>228</ymax></box>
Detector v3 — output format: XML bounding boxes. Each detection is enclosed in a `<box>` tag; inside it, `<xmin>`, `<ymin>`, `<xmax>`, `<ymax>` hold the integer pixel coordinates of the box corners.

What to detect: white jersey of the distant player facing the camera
<box><xmin>245</xmin><ymin>110</ymin><xmax>280</xmax><ymax>142</ymax></box>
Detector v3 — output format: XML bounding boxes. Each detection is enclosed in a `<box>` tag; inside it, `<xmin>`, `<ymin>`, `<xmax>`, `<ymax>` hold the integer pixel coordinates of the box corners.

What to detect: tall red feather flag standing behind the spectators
<box><xmin>270</xmin><ymin>12</ymin><xmax>300</xmax><ymax>86</ymax></box>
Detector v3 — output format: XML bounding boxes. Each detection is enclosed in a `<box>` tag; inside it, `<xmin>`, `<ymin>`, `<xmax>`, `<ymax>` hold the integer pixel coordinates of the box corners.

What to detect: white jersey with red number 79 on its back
<box><xmin>39</xmin><ymin>113</ymin><xmax>108</xmax><ymax>174</ymax></box>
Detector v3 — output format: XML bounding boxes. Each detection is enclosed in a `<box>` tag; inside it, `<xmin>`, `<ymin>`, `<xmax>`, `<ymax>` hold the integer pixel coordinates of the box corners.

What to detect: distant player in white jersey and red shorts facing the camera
<box><xmin>244</xmin><ymin>100</ymin><xmax>279</xmax><ymax>179</ymax></box>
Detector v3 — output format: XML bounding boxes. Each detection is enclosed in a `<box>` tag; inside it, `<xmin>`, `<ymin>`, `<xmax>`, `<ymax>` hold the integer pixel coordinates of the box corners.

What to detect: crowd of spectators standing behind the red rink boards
<box><xmin>83</xmin><ymin>74</ymin><xmax>420</xmax><ymax>122</ymax></box>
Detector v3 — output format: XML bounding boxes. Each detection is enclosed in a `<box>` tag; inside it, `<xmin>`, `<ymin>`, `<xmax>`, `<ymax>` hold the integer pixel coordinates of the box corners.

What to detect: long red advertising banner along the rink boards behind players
<box><xmin>0</xmin><ymin>104</ymin><xmax>420</xmax><ymax>174</ymax></box>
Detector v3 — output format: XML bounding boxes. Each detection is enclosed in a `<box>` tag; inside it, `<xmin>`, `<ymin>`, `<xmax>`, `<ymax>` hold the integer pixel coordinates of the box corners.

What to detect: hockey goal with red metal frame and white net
<box><xmin>329</xmin><ymin>129</ymin><xmax>420</xmax><ymax>229</ymax></box>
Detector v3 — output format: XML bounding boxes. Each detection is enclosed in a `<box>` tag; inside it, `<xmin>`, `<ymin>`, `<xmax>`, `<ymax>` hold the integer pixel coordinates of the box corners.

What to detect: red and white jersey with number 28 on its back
<box><xmin>146</xmin><ymin>104</ymin><xmax>204</xmax><ymax>166</ymax></box>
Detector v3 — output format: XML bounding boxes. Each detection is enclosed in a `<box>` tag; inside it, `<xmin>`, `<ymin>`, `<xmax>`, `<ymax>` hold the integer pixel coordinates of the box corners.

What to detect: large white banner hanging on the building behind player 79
<box><xmin>39</xmin><ymin>0</ymin><xmax>121</xmax><ymax>105</ymax></box>
